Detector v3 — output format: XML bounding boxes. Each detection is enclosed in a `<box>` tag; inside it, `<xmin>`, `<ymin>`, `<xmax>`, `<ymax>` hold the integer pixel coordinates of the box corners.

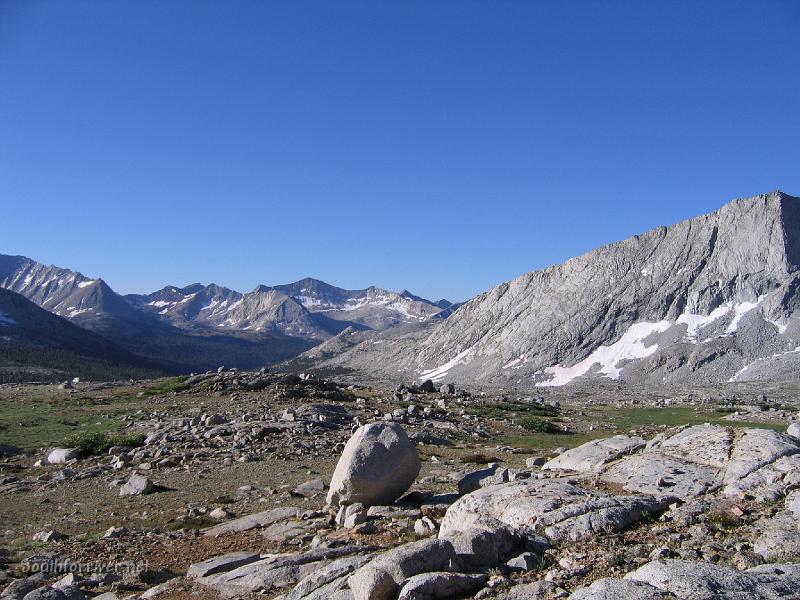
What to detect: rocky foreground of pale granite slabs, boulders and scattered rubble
<box><xmin>0</xmin><ymin>373</ymin><xmax>800</xmax><ymax>600</ymax></box>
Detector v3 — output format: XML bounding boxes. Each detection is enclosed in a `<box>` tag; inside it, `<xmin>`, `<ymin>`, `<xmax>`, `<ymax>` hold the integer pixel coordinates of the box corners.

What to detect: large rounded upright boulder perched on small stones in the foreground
<box><xmin>328</xmin><ymin>422</ymin><xmax>421</xmax><ymax>506</ymax></box>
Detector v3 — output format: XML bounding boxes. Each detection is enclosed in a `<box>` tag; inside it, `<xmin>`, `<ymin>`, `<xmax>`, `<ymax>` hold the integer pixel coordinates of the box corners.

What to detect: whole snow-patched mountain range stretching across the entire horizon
<box><xmin>6</xmin><ymin>192</ymin><xmax>800</xmax><ymax>388</ymax></box>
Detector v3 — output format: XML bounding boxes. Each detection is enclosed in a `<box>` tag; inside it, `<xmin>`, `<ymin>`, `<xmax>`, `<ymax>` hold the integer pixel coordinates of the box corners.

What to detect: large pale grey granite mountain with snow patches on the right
<box><xmin>304</xmin><ymin>192</ymin><xmax>800</xmax><ymax>387</ymax></box>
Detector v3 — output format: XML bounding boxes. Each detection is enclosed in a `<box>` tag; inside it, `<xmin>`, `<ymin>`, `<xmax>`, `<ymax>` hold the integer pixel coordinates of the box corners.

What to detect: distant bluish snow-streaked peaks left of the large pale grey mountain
<box><xmin>0</xmin><ymin>255</ymin><xmax>452</xmax><ymax>372</ymax></box>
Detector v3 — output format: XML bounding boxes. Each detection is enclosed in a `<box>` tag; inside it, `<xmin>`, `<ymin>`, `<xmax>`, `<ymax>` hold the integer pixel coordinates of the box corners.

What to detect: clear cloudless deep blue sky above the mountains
<box><xmin>0</xmin><ymin>0</ymin><xmax>800</xmax><ymax>300</ymax></box>
